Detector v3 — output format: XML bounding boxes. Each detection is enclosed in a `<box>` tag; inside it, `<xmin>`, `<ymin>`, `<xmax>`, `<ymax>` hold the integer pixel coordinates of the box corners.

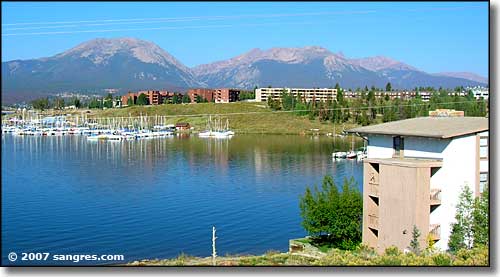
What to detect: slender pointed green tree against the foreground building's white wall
<box><xmin>448</xmin><ymin>185</ymin><xmax>474</xmax><ymax>252</ymax></box>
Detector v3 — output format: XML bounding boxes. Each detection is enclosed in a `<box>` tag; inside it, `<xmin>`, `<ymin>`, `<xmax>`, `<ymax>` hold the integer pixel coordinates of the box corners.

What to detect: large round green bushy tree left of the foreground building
<box><xmin>299</xmin><ymin>175</ymin><xmax>363</xmax><ymax>249</ymax></box>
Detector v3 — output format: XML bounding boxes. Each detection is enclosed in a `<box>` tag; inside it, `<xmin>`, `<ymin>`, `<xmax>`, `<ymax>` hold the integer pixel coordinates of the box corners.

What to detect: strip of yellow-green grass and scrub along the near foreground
<box><xmin>126</xmin><ymin>247</ymin><xmax>489</xmax><ymax>266</ymax></box>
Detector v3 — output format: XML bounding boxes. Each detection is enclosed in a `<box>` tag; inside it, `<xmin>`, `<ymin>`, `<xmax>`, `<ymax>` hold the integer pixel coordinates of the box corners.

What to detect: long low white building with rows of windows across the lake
<box><xmin>255</xmin><ymin>88</ymin><xmax>337</xmax><ymax>102</ymax></box>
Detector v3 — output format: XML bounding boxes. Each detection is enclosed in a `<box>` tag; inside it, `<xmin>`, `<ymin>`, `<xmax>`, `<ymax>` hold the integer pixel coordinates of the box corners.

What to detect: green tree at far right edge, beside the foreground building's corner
<box><xmin>472</xmin><ymin>186</ymin><xmax>489</xmax><ymax>247</ymax></box>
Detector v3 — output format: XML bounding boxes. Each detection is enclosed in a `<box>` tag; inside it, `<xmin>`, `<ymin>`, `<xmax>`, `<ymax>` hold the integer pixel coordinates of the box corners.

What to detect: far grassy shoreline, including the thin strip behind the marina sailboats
<box><xmin>2</xmin><ymin>102</ymin><xmax>358</xmax><ymax>135</ymax></box>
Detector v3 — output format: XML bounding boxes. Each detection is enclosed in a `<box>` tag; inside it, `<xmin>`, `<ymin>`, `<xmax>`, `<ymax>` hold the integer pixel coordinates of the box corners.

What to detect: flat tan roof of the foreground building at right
<box><xmin>347</xmin><ymin>117</ymin><xmax>488</xmax><ymax>139</ymax></box>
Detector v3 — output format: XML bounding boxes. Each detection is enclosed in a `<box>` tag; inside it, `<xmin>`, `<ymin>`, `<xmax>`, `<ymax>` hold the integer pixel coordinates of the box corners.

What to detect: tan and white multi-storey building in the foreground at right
<box><xmin>348</xmin><ymin>117</ymin><xmax>488</xmax><ymax>252</ymax></box>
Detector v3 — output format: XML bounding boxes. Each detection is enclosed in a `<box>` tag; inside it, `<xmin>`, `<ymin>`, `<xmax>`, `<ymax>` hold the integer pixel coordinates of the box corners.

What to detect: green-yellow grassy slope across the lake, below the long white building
<box><xmin>85</xmin><ymin>102</ymin><xmax>360</xmax><ymax>134</ymax></box>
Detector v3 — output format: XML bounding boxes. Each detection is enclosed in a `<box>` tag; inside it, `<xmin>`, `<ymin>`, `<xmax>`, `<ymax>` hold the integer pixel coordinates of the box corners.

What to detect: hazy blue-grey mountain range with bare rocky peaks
<box><xmin>2</xmin><ymin>38</ymin><xmax>488</xmax><ymax>102</ymax></box>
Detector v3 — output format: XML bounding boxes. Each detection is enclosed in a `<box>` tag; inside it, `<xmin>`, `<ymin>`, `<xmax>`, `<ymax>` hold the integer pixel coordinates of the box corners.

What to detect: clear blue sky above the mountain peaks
<box><xmin>2</xmin><ymin>2</ymin><xmax>488</xmax><ymax>76</ymax></box>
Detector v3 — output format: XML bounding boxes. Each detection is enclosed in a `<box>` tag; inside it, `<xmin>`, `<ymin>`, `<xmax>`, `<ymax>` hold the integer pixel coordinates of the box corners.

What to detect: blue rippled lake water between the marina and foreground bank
<box><xmin>2</xmin><ymin>134</ymin><xmax>362</xmax><ymax>265</ymax></box>
